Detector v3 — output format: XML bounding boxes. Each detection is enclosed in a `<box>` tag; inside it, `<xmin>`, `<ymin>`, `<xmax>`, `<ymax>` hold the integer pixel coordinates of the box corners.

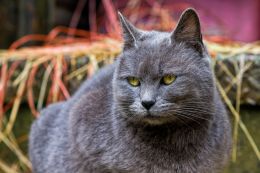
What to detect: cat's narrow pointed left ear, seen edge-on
<box><xmin>118</xmin><ymin>12</ymin><xmax>141</xmax><ymax>49</ymax></box>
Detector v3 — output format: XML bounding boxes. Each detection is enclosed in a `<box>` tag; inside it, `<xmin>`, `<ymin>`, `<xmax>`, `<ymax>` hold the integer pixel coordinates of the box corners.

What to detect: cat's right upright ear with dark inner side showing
<box><xmin>172</xmin><ymin>8</ymin><xmax>202</xmax><ymax>43</ymax></box>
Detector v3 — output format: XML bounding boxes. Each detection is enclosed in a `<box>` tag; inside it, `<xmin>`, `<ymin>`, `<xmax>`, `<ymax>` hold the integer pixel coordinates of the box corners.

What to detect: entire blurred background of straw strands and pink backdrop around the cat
<box><xmin>0</xmin><ymin>0</ymin><xmax>260</xmax><ymax>173</ymax></box>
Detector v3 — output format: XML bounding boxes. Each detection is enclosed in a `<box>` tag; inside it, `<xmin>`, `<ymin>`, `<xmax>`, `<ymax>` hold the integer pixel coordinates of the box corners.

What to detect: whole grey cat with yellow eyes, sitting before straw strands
<box><xmin>29</xmin><ymin>9</ymin><xmax>231</xmax><ymax>173</ymax></box>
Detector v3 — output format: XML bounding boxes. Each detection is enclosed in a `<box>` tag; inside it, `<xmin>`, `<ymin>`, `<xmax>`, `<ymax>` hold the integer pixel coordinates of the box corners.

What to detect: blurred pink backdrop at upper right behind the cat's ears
<box><xmin>118</xmin><ymin>0</ymin><xmax>260</xmax><ymax>42</ymax></box>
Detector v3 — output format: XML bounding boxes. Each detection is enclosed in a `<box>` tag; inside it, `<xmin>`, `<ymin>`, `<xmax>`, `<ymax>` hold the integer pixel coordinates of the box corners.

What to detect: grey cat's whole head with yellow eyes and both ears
<box><xmin>113</xmin><ymin>9</ymin><xmax>215</xmax><ymax>125</ymax></box>
